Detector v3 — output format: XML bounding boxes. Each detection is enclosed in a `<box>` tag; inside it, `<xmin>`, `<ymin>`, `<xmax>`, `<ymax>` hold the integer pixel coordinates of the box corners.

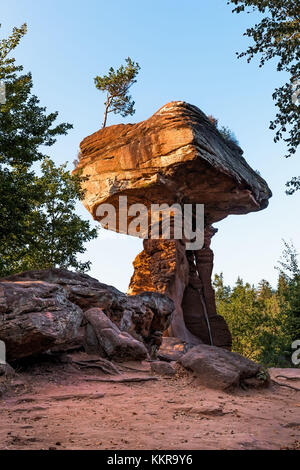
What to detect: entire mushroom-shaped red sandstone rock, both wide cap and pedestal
<box><xmin>75</xmin><ymin>101</ymin><xmax>271</xmax><ymax>349</ymax></box>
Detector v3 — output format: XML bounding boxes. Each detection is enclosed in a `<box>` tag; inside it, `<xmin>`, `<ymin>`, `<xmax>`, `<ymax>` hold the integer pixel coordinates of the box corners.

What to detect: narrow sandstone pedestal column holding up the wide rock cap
<box><xmin>128</xmin><ymin>226</ymin><xmax>231</xmax><ymax>349</ymax></box>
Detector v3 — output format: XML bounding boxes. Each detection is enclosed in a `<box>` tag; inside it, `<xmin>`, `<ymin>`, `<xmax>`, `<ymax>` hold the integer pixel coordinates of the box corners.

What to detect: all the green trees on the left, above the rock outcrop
<box><xmin>0</xmin><ymin>24</ymin><xmax>95</xmax><ymax>276</ymax></box>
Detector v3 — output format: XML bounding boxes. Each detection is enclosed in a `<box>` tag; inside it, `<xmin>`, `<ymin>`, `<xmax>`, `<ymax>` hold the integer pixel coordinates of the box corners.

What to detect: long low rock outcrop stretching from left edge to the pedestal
<box><xmin>0</xmin><ymin>269</ymin><xmax>174</xmax><ymax>361</ymax></box>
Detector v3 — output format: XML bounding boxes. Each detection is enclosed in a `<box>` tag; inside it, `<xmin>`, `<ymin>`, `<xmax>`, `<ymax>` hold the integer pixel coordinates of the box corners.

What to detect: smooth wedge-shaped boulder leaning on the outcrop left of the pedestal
<box><xmin>84</xmin><ymin>308</ymin><xmax>148</xmax><ymax>361</ymax></box>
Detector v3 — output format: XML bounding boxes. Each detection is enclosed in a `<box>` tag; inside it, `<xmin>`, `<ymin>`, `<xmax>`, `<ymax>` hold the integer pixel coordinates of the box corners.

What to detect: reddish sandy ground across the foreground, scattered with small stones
<box><xmin>0</xmin><ymin>356</ymin><xmax>300</xmax><ymax>450</ymax></box>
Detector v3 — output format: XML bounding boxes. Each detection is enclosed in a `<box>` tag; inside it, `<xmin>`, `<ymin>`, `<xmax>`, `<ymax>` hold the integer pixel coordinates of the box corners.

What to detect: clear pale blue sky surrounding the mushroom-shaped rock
<box><xmin>0</xmin><ymin>0</ymin><xmax>300</xmax><ymax>291</ymax></box>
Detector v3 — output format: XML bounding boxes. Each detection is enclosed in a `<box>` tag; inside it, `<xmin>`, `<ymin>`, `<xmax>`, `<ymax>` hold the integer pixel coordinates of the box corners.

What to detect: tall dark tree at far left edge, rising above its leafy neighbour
<box><xmin>0</xmin><ymin>24</ymin><xmax>71</xmax><ymax>245</ymax></box>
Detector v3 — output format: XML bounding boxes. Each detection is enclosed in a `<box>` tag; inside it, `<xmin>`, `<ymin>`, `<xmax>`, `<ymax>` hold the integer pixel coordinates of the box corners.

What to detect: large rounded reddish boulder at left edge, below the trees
<box><xmin>0</xmin><ymin>280</ymin><xmax>82</xmax><ymax>361</ymax></box>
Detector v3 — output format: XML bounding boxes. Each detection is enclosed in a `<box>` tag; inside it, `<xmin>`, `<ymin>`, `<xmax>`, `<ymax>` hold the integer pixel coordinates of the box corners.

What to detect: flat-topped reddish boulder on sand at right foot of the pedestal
<box><xmin>178</xmin><ymin>344</ymin><xmax>261</xmax><ymax>390</ymax></box>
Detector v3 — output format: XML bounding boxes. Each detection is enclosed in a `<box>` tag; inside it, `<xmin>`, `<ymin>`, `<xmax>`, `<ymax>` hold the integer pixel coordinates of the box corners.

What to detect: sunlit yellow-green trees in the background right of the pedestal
<box><xmin>214</xmin><ymin>243</ymin><xmax>300</xmax><ymax>367</ymax></box>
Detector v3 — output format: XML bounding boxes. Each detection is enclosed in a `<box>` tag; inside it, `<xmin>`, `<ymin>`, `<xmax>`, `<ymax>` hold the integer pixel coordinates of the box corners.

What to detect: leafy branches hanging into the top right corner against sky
<box><xmin>227</xmin><ymin>0</ymin><xmax>300</xmax><ymax>160</ymax></box>
